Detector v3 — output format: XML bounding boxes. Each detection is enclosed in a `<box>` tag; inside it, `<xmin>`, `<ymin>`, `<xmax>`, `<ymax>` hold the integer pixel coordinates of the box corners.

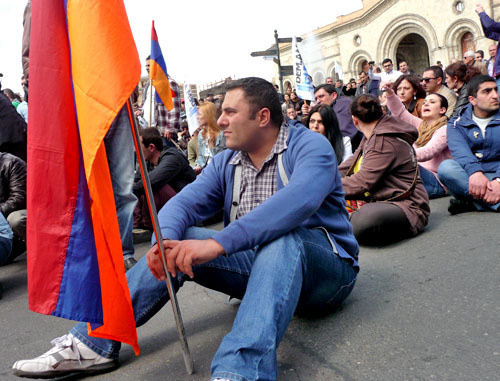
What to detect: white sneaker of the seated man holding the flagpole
<box><xmin>12</xmin><ymin>333</ymin><xmax>118</xmax><ymax>378</ymax></box>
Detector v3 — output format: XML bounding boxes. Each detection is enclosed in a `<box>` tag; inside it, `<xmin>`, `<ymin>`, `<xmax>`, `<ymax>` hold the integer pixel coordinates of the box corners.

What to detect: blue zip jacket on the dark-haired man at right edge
<box><xmin>446</xmin><ymin>103</ymin><xmax>500</xmax><ymax>177</ymax></box>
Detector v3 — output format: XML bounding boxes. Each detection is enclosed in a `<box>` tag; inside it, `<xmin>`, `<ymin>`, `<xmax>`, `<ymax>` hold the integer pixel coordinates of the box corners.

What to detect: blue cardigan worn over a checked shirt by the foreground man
<box><xmin>158</xmin><ymin>127</ymin><xmax>359</xmax><ymax>267</ymax></box>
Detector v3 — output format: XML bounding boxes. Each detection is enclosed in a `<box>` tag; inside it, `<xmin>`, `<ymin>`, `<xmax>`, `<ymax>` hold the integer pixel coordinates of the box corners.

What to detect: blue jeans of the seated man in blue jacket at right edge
<box><xmin>438</xmin><ymin>160</ymin><xmax>500</xmax><ymax>211</ymax></box>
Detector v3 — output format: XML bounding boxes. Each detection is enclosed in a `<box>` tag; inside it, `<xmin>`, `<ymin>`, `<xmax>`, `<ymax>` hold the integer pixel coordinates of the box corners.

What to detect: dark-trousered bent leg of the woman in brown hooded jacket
<box><xmin>351</xmin><ymin>201</ymin><xmax>413</xmax><ymax>245</ymax></box>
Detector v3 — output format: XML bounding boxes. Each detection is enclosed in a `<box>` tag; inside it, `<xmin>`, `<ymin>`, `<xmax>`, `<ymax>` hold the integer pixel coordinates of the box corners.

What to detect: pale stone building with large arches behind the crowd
<box><xmin>274</xmin><ymin>0</ymin><xmax>500</xmax><ymax>88</ymax></box>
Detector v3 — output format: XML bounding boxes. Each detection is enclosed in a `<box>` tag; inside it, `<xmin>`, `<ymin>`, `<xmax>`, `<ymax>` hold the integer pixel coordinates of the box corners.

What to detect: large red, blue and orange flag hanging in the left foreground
<box><xmin>27</xmin><ymin>0</ymin><xmax>140</xmax><ymax>353</ymax></box>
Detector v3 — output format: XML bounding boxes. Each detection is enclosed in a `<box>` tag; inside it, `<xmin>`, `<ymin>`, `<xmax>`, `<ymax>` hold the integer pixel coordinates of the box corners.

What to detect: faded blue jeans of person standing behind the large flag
<box><xmin>104</xmin><ymin>106</ymin><xmax>137</xmax><ymax>259</ymax></box>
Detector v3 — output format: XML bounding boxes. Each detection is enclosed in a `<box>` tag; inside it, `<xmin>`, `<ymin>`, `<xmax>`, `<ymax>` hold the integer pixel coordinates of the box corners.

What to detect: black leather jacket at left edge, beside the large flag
<box><xmin>0</xmin><ymin>152</ymin><xmax>26</xmax><ymax>217</ymax></box>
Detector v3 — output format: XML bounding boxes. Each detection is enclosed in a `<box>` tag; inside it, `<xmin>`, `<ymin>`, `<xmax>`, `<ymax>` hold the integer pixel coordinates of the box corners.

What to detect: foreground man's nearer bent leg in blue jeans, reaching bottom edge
<box><xmin>211</xmin><ymin>228</ymin><xmax>357</xmax><ymax>380</ymax></box>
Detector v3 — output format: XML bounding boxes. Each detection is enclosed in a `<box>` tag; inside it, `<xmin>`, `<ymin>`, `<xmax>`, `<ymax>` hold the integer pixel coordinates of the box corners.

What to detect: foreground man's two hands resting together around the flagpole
<box><xmin>146</xmin><ymin>239</ymin><xmax>224</xmax><ymax>280</ymax></box>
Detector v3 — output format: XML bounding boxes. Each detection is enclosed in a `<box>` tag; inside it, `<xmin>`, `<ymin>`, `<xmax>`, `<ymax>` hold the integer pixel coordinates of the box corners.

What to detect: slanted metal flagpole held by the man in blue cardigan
<box><xmin>127</xmin><ymin>98</ymin><xmax>194</xmax><ymax>374</ymax></box>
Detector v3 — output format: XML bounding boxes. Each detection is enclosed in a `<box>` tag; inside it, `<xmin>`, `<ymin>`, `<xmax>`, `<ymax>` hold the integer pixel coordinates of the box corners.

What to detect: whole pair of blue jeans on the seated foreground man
<box><xmin>71</xmin><ymin>227</ymin><xmax>357</xmax><ymax>380</ymax></box>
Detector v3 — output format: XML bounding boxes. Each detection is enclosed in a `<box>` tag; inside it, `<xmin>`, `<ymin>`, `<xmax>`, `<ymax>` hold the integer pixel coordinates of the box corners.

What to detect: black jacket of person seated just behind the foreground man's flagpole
<box><xmin>133</xmin><ymin>147</ymin><xmax>196</xmax><ymax>194</ymax></box>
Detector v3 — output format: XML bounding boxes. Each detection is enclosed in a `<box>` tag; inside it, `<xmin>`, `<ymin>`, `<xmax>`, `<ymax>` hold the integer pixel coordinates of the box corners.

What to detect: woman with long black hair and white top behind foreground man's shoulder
<box><xmin>306</xmin><ymin>104</ymin><xmax>352</xmax><ymax>164</ymax></box>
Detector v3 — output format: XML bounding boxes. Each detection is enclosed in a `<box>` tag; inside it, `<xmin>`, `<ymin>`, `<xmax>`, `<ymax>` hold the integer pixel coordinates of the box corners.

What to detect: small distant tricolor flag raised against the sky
<box><xmin>149</xmin><ymin>21</ymin><xmax>175</xmax><ymax>111</ymax></box>
